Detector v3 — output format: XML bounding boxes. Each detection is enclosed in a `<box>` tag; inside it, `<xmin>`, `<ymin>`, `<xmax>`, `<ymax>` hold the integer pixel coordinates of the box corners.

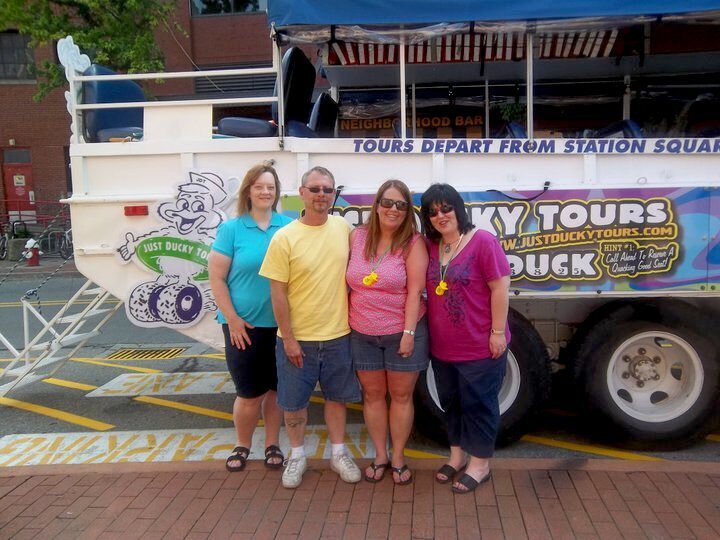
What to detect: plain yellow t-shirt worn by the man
<box><xmin>260</xmin><ymin>216</ymin><xmax>350</xmax><ymax>341</ymax></box>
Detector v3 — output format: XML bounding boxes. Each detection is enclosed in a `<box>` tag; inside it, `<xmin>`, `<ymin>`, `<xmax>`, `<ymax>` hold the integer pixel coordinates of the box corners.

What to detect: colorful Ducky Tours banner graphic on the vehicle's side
<box><xmin>335</xmin><ymin>188</ymin><xmax>720</xmax><ymax>293</ymax></box>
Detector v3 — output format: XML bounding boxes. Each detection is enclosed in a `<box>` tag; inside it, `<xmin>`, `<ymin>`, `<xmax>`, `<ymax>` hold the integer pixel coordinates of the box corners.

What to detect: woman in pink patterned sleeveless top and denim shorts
<box><xmin>347</xmin><ymin>180</ymin><xmax>428</xmax><ymax>485</ymax></box>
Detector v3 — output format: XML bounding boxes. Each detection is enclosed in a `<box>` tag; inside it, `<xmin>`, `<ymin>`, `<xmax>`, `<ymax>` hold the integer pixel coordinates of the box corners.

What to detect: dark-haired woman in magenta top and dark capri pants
<box><xmin>421</xmin><ymin>184</ymin><xmax>510</xmax><ymax>493</ymax></box>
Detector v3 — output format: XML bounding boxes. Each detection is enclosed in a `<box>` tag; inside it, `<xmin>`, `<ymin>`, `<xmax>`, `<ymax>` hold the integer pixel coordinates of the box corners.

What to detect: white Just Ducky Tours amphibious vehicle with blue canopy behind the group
<box><xmin>5</xmin><ymin>0</ymin><xmax>720</xmax><ymax>449</ymax></box>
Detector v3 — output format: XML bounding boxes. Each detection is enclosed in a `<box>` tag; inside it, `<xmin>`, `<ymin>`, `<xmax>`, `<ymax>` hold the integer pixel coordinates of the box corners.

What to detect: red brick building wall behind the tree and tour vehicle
<box><xmin>0</xmin><ymin>0</ymin><xmax>272</xmax><ymax>221</ymax></box>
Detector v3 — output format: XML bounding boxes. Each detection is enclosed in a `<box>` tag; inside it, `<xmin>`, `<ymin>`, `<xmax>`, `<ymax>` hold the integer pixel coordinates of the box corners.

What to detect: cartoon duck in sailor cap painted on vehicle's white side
<box><xmin>117</xmin><ymin>172</ymin><xmax>239</xmax><ymax>328</ymax></box>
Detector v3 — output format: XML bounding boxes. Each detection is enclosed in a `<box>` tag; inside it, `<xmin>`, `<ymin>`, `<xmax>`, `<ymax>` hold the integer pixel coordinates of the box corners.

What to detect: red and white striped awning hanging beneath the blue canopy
<box><xmin>324</xmin><ymin>29</ymin><xmax>618</xmax><ymax>66</ymax></box>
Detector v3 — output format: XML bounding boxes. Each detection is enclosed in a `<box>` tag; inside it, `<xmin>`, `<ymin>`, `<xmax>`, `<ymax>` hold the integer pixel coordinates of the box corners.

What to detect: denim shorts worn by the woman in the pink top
<box><xmin>350</xmin><ymin>317</ymin><xmax>430</xmax><ymax>371</ymax></box>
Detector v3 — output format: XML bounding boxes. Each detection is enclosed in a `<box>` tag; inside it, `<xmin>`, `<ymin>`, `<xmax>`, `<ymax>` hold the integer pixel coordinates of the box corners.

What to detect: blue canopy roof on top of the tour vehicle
<box><xmin>268</xmin><ymin>0</ymin><xmax>720</xmax><ymax>28</ymax></box>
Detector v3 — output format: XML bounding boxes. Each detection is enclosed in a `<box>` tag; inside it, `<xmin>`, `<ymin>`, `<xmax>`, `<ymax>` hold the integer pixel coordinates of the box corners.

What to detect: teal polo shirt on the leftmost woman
<box><xmin>212</xmin><ymin>212</ymin><xmax>293</xmax><ymax>328</ymax></box>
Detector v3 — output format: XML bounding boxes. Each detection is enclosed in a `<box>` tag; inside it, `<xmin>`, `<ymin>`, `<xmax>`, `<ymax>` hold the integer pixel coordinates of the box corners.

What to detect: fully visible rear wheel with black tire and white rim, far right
<box><xmin>575</xmin><ymin>301</ymin><xmax>720</xmax><ymax>450</ymax></box>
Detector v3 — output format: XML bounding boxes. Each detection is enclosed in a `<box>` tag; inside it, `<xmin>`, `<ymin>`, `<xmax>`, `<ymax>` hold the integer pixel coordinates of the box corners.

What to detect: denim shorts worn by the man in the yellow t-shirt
<box><xmin>275</xmin><ymin>335</ymin><xmax>360</xmax><ymax>411</ymax></box>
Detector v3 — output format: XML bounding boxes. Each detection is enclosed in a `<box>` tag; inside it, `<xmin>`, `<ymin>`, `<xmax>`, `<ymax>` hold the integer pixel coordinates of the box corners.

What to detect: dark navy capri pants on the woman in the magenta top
<box><xmin>432</xmin><ymin>351</ymin><xmax>507</xmax><ymax>458</ymax></box>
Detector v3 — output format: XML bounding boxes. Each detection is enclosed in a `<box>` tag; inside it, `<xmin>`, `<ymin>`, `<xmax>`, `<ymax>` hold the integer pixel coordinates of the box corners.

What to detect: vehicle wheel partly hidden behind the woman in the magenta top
<box><xmin>415</xmin><ymin>309</ymin><xmax>551</xmax><ymax>446</ymax></box>
